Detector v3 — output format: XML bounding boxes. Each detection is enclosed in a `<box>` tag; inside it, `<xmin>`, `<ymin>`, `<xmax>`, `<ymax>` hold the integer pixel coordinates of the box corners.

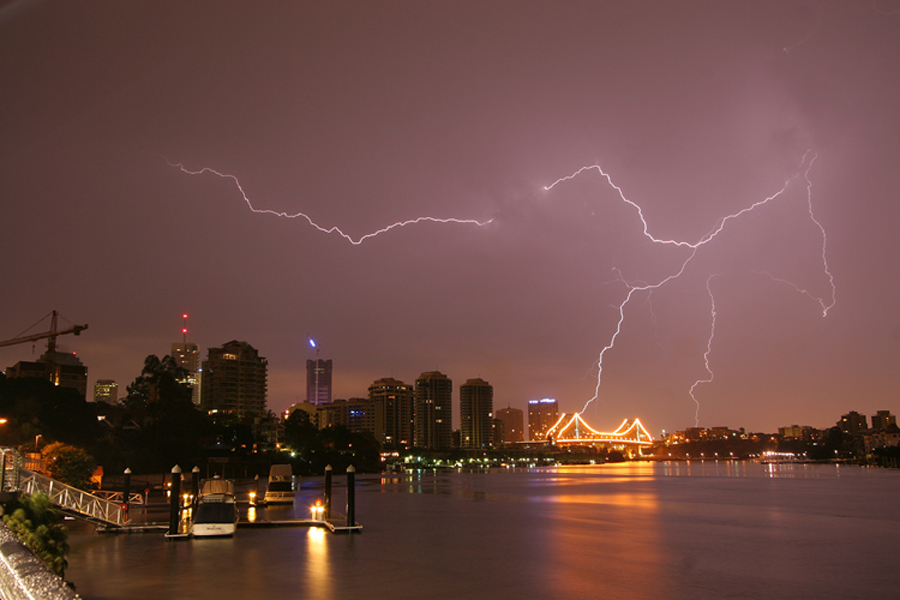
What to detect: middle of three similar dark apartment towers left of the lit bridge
<box><xmin>415</xmin><ymin>371</ymin><xmax>453</xmax><ymax>450</ymax></box>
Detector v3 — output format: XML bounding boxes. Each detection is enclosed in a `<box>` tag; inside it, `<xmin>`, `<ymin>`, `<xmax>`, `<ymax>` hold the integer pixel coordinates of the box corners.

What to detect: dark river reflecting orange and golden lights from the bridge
<box><xmin>66</xmin><ymin>461</ymin><xmax>900</xmax><ymax>600</ymax></box>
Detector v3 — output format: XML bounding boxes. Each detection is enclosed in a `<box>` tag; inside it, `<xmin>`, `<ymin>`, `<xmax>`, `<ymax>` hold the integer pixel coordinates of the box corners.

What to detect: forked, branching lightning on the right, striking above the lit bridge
<box><xmin>544</xmin><ymin>151</ymin><xmax>836</xmax><ymax>423</ymax></box>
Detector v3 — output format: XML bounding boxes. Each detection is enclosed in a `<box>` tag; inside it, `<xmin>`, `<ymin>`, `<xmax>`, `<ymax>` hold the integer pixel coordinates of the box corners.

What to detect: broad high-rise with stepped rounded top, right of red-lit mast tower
<box><xmin>200</xmin><ymin>340</ymin><xmax>268</xmax><ymax>418</ymax></box>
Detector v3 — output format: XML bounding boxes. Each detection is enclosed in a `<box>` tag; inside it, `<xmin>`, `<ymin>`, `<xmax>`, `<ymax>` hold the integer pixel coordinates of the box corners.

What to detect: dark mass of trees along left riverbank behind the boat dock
<box><xmin>0</xmin><ymin>355</ymin><xmax>380</xmax><ymax>486</ymax></box>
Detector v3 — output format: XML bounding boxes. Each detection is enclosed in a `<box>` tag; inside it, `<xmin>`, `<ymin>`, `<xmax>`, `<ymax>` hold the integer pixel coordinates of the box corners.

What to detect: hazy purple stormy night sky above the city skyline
<box><xmin>0</xmin><ymin>0</ymin><xmax>900</xmax><ymax>435</ymax></box>
